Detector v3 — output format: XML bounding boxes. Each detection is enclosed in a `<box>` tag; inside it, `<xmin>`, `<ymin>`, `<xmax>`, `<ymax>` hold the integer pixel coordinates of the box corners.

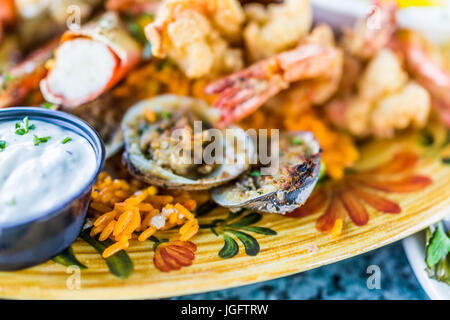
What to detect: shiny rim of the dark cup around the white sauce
<box><xmin>0</xmin><ymin>107</ymin><xmax>105</xmax><ymax>229</ymax></box>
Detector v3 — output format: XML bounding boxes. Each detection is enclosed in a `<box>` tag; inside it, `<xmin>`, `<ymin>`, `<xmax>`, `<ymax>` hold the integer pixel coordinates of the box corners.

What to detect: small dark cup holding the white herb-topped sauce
<box><xmin>0</xmin><ymin>107</ymin><xmax>105</xmax><ymax>270</ymax></box>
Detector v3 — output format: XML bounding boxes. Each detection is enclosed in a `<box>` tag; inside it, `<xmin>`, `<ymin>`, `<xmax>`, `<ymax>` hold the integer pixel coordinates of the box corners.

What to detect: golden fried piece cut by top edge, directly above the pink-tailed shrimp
<box><xmin>244</xmin><ymin>0</ymin><xmax>312</xmax><ymax>61</ymax></box>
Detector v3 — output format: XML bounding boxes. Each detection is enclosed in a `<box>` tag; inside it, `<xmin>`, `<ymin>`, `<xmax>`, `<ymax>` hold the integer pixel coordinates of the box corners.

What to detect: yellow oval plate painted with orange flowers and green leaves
<box><xmin>0</xmin><ymin>127</ymin><xmax>450</xmax><ymax>299</ymax></box>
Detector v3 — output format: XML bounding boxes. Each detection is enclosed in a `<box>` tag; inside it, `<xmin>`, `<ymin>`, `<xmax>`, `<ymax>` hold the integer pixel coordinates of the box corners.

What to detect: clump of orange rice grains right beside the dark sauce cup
<box><xmin>89</xmin><ymin>172</ymin><xmax>199</xmax><ymax>258</ymax></box>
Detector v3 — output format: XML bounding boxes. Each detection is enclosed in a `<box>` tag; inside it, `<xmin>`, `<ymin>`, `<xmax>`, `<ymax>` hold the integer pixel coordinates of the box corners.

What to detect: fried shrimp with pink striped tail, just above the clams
<box><xmin>205</xmin><ymin>25</ymin><xmax>342</xmax><ymax>125</ymax></box>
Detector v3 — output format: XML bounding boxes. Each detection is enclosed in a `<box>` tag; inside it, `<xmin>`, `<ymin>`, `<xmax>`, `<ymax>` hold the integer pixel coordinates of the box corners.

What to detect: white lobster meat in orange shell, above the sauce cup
<box><xmin>40</xmin><ymin>13</ymin><xmax>142</xmax><ymax>107</ymax></box>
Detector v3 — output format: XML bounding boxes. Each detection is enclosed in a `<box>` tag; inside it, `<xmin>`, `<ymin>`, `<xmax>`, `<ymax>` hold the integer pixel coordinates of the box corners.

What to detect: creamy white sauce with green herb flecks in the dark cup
<box><xmin>0</xmin><ymin>118</ymin><xmax>96</xmax><ymax>226</ymax></box>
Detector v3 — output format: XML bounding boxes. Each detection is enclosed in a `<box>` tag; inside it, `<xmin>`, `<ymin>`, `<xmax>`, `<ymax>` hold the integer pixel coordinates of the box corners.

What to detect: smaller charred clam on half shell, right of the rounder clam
<box><xmin>212</xmin><ymin>132</ymin><xmax>321</xmax><ymax>214</ymax></box>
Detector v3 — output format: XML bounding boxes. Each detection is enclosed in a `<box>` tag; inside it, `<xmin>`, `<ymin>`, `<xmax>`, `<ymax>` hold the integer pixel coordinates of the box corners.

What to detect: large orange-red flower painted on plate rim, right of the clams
<box><xmin>287</xmin><ymin>151</ymin><xmax>432</xmax><ymax>236</ymax></box>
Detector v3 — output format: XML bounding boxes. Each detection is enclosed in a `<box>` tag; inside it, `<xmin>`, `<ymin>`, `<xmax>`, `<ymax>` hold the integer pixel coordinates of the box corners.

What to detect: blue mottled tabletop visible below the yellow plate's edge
<box><xmin>175</xmin><ymin>242</ymin><xmax>428</xmax><ymax>300</ymax></box>
